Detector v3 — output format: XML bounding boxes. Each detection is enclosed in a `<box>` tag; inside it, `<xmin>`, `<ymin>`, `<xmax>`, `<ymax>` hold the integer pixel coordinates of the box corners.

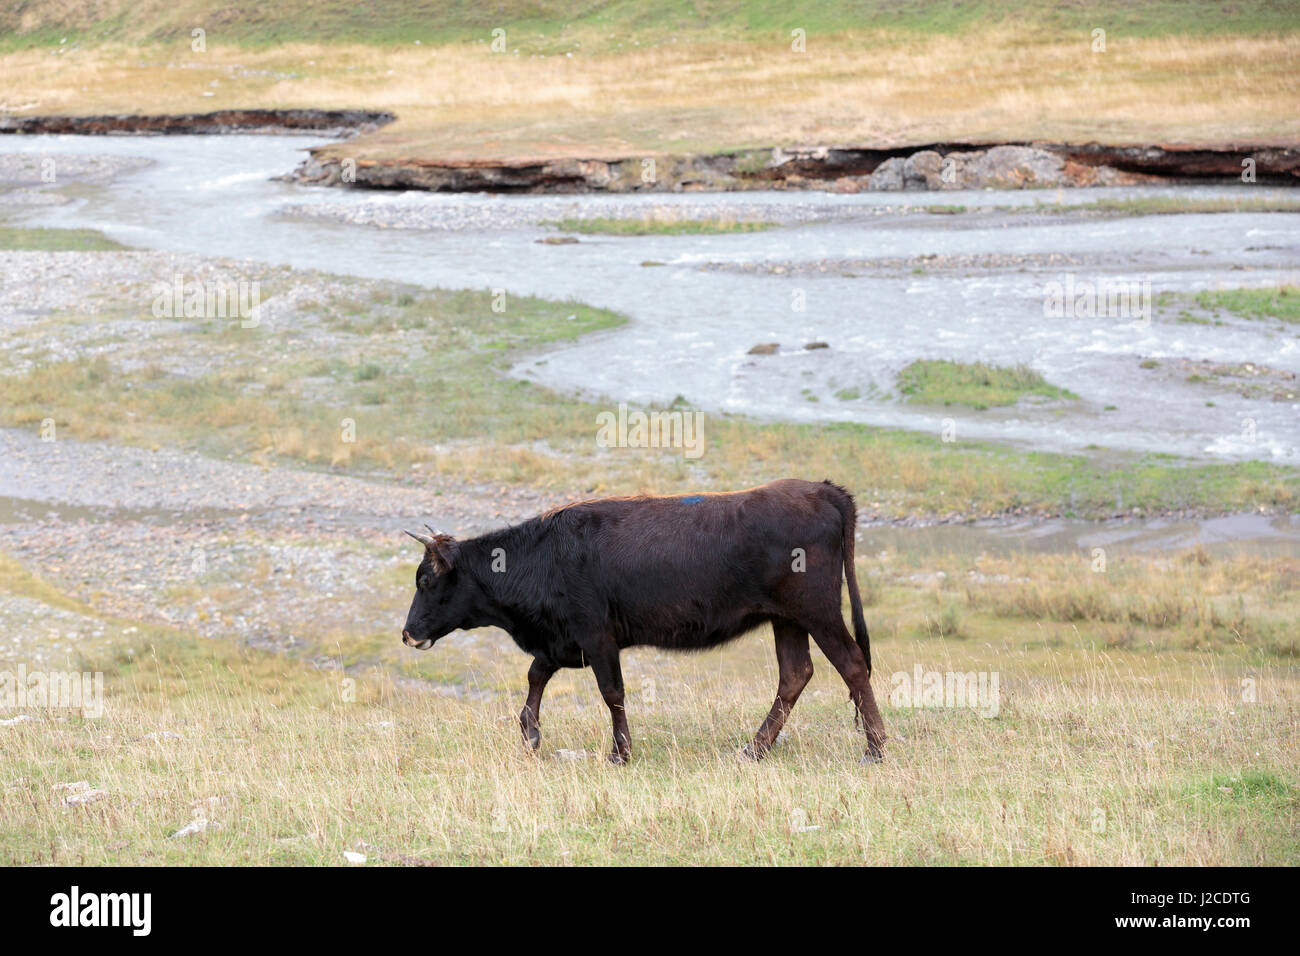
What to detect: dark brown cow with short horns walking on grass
<box><xmin>402</xmin><ymin>479</ymin><xmax>885</xmax><ymax>763</ymax></box>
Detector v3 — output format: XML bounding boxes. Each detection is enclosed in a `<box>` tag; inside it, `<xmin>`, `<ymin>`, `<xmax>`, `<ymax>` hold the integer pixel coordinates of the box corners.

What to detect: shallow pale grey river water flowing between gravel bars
<box><xmin>0</xmin><ymin>135</ymin><xmax>1300</xmax><ymax>463</ymax></box>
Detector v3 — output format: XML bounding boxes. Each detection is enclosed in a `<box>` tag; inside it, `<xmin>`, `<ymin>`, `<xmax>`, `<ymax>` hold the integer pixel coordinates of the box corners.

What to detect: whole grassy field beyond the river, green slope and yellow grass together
<box><xmin>0</xmin><ymin>0</ymin><xmax>1300</xmax><ymax>161</ymax></box>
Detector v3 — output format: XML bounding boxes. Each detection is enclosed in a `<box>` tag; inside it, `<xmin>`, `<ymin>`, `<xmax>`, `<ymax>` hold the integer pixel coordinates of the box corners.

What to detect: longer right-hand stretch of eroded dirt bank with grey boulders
<box><xmin>289</xmin><ymin>143</ymin><xmax>1300</xmax><ymax>193</ymax></box>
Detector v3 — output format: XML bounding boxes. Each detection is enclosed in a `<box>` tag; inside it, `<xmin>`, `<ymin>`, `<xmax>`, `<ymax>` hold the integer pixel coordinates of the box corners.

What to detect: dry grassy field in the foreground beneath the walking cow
<box><xmin>0</xmin><ymin>530</ymin><xmax>1300</xmax><ymax>866</ymax></box>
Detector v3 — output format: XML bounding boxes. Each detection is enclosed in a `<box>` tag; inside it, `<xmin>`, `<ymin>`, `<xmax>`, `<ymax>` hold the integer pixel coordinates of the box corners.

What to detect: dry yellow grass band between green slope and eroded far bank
<box><xmin>0</xmin><ymin>27</ymin><xmax>1300</xmax><ymax>159</ymax></box>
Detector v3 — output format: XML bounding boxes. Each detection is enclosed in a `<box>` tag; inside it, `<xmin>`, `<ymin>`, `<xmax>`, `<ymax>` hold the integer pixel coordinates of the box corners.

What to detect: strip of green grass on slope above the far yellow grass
<box><xmin>0</xmin><ymin>0</ymin><xmax>1296</xmax><ymax>52</ymax></box>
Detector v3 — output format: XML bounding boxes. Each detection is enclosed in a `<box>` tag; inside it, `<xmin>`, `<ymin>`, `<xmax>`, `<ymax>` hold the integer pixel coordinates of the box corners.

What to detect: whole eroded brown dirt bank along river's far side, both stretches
<box><xmin>0</xmin><ymin>109</ymin><xmax>1300</xmax><ymax>193</ymax></box>
